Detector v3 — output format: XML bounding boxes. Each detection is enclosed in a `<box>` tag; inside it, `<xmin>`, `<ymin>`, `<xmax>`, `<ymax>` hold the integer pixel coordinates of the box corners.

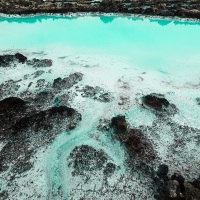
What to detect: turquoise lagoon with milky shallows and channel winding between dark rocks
<box><xmin>0</xmin><ymin>15</ymin><xmax>200</xmax><ymax>199</ymax></box>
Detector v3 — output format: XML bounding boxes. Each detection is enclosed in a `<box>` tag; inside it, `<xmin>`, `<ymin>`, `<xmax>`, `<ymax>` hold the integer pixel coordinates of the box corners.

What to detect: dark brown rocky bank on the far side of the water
<box><xmin>0</xmin><ymin>0</ymin><xmax>200</xmax><ymax>19</ymax></box>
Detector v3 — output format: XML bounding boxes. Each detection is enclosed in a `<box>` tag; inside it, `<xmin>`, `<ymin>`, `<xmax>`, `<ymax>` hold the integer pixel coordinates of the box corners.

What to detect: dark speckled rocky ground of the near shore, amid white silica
<box><xmin>0</xmin><ymin>53</ymin><xmax>200</xmax><ymax>200</ymax></box>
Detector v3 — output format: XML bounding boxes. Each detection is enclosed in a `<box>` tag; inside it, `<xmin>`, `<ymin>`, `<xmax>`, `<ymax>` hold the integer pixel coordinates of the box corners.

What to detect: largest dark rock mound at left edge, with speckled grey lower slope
<box><xmin>0</xmin><ymin>97</ymin><xmax>81</xmax><ymax>174</ymax></box>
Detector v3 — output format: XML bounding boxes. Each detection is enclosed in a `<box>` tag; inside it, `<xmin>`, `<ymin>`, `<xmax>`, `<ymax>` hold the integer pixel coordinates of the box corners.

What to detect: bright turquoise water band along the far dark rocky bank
<box><xmin>0</xmin><ymin>16</ymin><xmax>200</xmax><ymax>72</ymax></box>
